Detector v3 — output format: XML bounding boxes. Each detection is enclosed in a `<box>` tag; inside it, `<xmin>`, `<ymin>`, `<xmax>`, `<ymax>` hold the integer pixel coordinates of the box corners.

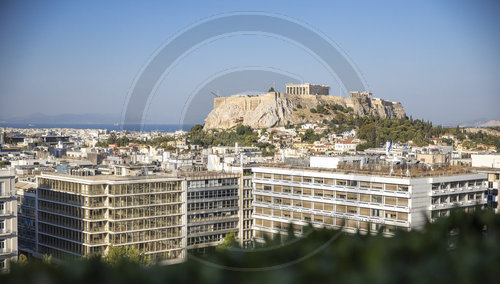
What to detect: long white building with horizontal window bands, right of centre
<box><xmin>252</xmin><ymin>166</ymin><xmax>487</xmax><ymax>241</ymax></box>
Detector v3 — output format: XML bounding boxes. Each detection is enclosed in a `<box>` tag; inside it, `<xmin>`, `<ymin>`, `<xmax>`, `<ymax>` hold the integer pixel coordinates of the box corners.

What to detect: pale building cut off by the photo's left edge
<box><xmin>0</xmin><ymin>169</ymin><xmax>17</xmax><ymax>273</ymax></box>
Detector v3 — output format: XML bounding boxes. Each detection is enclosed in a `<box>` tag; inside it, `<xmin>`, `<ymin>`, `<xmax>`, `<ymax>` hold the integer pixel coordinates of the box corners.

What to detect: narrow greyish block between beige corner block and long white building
<box><xmin>184</xmin><ymin>172</ymin><xmax>241</xmax><ymax>254</ymax></box>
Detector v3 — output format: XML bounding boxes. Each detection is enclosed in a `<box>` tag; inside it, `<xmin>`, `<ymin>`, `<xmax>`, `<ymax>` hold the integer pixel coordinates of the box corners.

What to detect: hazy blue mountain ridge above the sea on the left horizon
<box><xmin>0</xmin><ymin>113</ymin><xmax>121</xmax><ymax>124</ymax></box>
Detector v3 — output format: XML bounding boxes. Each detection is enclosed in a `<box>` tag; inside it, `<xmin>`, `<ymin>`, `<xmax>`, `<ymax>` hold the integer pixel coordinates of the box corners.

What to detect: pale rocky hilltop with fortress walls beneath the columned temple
<box><xmin>205</xmin><ymin>92</ymin><xmax>406</xmax><ymax>129</ymax></box>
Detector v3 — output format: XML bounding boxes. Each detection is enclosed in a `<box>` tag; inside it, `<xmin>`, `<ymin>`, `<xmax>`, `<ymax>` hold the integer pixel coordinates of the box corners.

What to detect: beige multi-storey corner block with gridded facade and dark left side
<box><xmin>37</xmin><ymin>174</ymin><xmax>186</xmax><ymax>263</ymax></box>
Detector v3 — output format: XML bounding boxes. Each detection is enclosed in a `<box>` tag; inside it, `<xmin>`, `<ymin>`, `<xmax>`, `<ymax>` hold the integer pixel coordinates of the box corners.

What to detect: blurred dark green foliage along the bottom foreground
<box><xmin>0</xmin><ymin>211</ymin><xmax>500</xmax><ymax>284</ymax></box>
